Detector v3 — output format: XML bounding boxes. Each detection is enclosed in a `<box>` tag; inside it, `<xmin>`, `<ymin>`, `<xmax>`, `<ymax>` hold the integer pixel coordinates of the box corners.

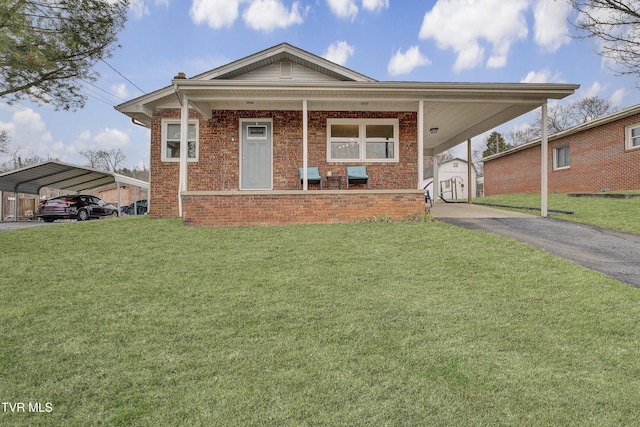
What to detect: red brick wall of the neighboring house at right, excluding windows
<box><xmin>484</xmin><ymin>115</ymin><xmax>640</xmax><ymax>196</ymax></box>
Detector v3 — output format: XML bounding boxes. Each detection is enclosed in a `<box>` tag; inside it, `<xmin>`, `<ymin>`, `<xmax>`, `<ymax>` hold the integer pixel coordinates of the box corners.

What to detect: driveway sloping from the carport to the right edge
<box><xmin>433</xmin><ymin>207</ymin><xmax>640</xmax><ymax>287</ymax></box>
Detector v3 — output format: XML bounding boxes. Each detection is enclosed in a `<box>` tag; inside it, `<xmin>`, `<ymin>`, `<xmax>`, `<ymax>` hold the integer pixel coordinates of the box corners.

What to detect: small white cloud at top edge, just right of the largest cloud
<box><xmin>533</xmin><ymin>0</ymin><xmax>573</xmax><ymax>52</ymax></box>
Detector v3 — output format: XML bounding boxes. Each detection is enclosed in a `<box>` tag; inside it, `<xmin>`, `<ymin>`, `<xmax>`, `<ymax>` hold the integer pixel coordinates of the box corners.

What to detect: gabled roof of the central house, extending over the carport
<box><xmin>115</xmin><ymin>43</ymin><xmax>579</xmax><ymax>156</ymax></box>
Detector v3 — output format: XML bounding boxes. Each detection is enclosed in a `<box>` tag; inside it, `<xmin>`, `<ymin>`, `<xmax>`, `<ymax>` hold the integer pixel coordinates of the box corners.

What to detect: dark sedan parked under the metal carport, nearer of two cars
<box><xmin>36</xmin><ymin>194</ymin><xmax>118</xmax><ymax>222</ymax></box>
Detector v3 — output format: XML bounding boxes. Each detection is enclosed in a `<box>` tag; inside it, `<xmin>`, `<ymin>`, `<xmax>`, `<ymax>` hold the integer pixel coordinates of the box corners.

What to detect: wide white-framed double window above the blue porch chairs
<box><xmin>327</xmin><ymin>119</ymin><xmax>400</xmax><ymax>162</ymax></box>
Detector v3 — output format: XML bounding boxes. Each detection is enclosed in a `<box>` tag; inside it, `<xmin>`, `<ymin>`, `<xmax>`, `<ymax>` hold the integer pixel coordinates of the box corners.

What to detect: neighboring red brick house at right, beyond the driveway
<box><xmin>482</xmin><ymin>105</ymin><xmax>640</xmax><ymax>196</ymax></box>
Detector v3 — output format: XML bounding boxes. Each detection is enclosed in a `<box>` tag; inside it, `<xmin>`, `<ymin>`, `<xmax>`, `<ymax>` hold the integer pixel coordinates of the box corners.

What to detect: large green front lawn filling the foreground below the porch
<box><xmin>0</xmin><ymin>217</ymin><xmax>640</xmax><ymax>426</ymax></box>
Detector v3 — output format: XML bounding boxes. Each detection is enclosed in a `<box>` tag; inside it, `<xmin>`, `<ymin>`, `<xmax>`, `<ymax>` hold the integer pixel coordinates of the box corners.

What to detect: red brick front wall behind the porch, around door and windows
<box><xmin>150</xmin><ymin>109</ymin><xmax>418</xmax><ymax>217</ymax></box>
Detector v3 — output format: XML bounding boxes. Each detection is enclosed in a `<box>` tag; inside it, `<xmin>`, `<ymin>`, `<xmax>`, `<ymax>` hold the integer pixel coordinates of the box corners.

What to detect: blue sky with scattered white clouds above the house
<box><xmin>0</xmin><ymin>0</ymin><xmax>640</xmax><ymax>167</ymax></box>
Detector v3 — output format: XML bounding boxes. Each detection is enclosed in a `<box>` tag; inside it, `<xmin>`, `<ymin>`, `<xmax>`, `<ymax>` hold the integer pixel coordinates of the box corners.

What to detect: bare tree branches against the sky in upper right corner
<box><xmin>570</xmin><ymin>0</ymin><xmax>640</xmax><ymax>76</ymax></box>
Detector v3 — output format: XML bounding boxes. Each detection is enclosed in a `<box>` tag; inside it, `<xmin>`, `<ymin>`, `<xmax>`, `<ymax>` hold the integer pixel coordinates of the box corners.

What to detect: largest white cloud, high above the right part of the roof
<box><xmin>419</xmin><ymin>0</ymin><xmax>528</xmax><ymax>71</ymax></box>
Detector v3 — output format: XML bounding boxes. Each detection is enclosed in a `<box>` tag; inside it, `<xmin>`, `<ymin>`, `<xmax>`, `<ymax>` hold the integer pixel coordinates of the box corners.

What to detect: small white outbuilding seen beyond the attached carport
<box><xmin>422</xmin><ymin>158</ymin><xmax>478</xmax><ymax>200</ymax></box>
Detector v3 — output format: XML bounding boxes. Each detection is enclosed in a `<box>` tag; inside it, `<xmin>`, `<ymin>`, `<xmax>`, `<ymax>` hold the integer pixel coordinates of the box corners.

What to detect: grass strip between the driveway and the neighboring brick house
<box><xmin>475</xmin><ymin>194</ymin><xmax>640</xmax><ymax>234</ymax></box>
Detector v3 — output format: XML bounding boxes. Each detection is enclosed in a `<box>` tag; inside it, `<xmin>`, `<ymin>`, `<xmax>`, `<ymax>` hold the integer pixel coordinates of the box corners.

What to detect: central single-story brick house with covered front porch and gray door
<box><xmin>116</xmin><ymin>43</ymin><xmax>578</xmax><ymax>226</ymax></box>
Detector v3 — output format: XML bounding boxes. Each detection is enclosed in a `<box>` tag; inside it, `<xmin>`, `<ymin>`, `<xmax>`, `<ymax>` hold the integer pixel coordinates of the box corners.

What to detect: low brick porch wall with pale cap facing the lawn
<box><xmin>182</xmin><ymin>190</ymin><xmax>426</xmax><ymax>227</ymax></box>
